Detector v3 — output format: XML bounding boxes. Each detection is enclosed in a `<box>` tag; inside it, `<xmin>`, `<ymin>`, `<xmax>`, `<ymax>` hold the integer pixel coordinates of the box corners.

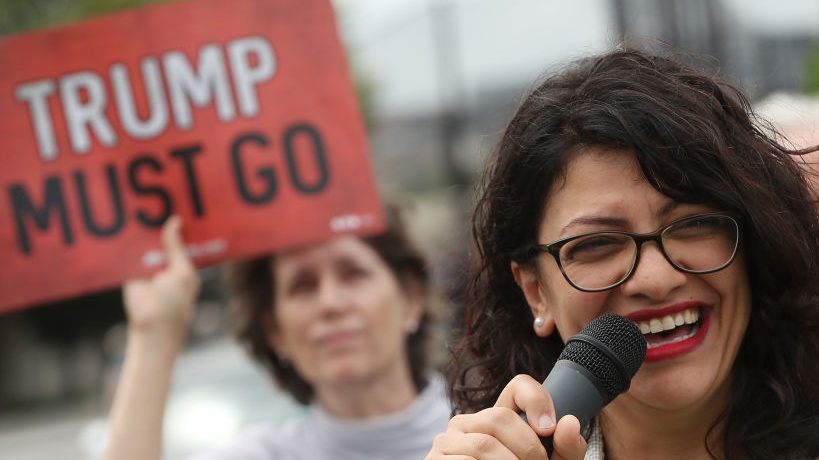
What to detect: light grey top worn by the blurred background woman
<box><xmin>191</xmin><ymin>374</ymin><xmax>450</xmax><ymax>460</ymax></box>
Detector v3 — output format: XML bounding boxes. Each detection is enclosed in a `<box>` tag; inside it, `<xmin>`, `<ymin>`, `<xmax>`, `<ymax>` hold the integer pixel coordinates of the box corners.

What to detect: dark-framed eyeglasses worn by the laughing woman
<box><xmin>529</xmin><ymin>212</ymin><xmax>739</xmax><ymax>292</ymax></box>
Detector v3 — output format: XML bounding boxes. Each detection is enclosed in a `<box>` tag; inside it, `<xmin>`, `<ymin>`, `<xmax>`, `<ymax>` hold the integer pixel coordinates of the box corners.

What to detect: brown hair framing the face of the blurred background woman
<box><xmin>227</xmin><ymin>202</ymin><xmax>439</xmax><ymax>404</ymax></box>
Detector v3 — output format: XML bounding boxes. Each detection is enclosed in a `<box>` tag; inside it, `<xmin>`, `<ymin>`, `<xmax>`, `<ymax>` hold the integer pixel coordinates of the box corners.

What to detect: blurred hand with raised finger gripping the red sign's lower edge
<box><xmin>123</xmin><ymin>216</ymin><xmax>200</xmax><ymax>342</ymax></box>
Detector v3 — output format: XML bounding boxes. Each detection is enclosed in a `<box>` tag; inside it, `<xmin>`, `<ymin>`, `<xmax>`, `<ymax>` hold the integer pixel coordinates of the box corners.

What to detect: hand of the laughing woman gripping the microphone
<box><xmin>426</xmin><ymin>375</ymin><xmax>586</xmax><ymax>460</ymax></box>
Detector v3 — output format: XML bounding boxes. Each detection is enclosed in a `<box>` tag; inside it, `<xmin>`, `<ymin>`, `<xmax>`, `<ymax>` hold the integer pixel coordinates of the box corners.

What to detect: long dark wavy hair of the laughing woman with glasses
<box><xmin>448</xmin><ymin>44</ymin><xmax>819</xmax><ymax>459</ymax></box>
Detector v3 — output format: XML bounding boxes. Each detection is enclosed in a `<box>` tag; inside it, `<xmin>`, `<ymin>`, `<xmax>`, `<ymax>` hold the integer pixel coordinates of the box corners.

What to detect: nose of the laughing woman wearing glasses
<box><xmin>620</xmin><ymin>241</ymin><xmax>687</xmax><ymax>299</ymax></box>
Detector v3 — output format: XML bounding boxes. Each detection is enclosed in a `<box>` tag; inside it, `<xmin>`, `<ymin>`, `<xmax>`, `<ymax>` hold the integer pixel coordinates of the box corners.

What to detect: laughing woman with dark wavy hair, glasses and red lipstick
<box><xmin>427</xmin><ymin>41</ymin><xmax>819</xmax><ymax>460</ymax></box>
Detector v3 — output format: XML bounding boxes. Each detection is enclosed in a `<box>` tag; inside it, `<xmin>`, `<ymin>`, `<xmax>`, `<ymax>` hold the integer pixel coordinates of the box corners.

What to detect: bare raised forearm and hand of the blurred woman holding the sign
<box><xmin>103</xmin><ymin>216</ymin><xmax>200</xmax><ymax>460</ymax></box>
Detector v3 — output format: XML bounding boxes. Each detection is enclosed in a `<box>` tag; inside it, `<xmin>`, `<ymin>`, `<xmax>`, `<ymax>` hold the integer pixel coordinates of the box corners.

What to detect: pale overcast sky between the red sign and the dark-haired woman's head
<box><xmin>326</xmin><ymin>0</ymin><xmax>613</xmax><ymax>115</ymax></box>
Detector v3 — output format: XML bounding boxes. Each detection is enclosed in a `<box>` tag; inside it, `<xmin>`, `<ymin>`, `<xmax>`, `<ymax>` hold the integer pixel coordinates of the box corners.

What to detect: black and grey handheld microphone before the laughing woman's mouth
<box><xmin>524</xmin><ymin>313</ymin><xmax>647</xmax><ymax>456</ymax></box>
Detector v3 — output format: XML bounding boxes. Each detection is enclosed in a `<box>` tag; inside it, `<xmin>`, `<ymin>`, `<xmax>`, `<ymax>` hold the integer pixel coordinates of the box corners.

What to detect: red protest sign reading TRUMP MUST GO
<box><xmin>0</xmin><ymin>0</ymin><xmax>384</xmax><ymax>312</ymax></box>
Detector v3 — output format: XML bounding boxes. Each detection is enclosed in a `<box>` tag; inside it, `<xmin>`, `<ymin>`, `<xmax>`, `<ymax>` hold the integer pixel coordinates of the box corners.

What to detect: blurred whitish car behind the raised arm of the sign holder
<box><xmin>77</xmin><ymin>338</ymin><xmax>305</xmax><ymax>460</ymax></box>
